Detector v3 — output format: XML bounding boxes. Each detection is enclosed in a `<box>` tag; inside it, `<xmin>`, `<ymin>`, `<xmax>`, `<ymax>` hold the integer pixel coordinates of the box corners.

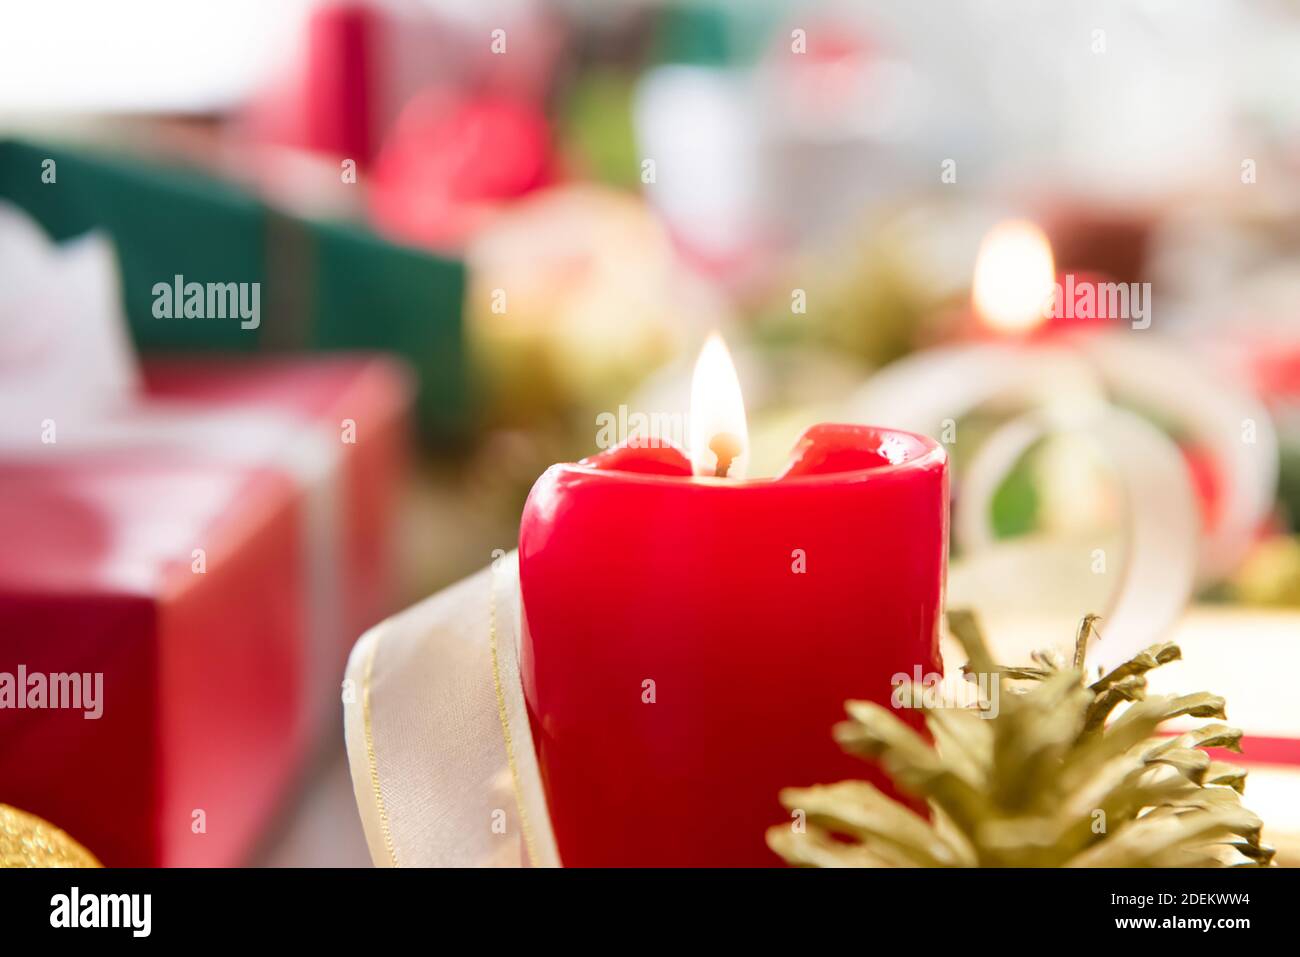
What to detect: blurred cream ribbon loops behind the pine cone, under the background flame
<box><xmin>849</xmin><ymin>335</ymin><xmax>1277</xmax><ymax>663</ymax></box>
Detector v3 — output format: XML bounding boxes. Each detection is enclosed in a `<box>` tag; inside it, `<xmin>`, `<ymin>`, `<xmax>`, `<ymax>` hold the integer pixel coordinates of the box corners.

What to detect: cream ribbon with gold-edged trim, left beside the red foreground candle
<box><xmin>343</xmin><ymin>553</ymin><xmax>559</xmax><ymax>867</ymax></box>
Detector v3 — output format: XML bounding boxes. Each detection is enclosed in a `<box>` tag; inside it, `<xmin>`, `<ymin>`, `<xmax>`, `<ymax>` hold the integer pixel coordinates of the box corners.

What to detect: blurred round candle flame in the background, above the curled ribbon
<box><xmin>971</xmin><ymin>220</ymin><xmax>1056</xmax><ymax>334</ymax></box>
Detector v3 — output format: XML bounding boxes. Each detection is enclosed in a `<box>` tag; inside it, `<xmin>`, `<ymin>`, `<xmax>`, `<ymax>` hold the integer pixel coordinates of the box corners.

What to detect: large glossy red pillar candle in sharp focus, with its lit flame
<box><xmin>519</xmin><ymin>339</ymin><xmax>948</xmax><ymax>866</ymax></box>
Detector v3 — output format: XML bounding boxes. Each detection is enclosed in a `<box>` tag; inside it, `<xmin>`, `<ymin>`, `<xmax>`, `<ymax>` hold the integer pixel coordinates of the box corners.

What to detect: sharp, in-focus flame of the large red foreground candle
<box><xmin>690</xmin><ymin>333</ymin><xmax>749</xmax><ymax>479</ymax></box>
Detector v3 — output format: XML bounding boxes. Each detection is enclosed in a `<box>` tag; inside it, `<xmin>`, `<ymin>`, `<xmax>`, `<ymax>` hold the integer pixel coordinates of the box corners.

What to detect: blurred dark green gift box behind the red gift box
<box><xmin>0</xmin><ymin>140</ymin><xmax>471</xmax><ymax>442</ymax></box>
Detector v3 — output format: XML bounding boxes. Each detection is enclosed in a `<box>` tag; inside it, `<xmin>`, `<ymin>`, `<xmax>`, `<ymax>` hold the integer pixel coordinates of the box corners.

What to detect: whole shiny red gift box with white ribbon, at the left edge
<box><xmin>0</xmin><ymin>359</ymin><xmax>410</xmax><ymax>865</ymax></box>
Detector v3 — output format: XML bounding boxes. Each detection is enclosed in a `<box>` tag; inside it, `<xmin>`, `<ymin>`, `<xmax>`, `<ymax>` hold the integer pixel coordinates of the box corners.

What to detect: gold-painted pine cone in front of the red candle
<box><xmin>767</xmin><ymin>612</ymin><xmax>1274</xmax><ymax>867</ymax></box>
